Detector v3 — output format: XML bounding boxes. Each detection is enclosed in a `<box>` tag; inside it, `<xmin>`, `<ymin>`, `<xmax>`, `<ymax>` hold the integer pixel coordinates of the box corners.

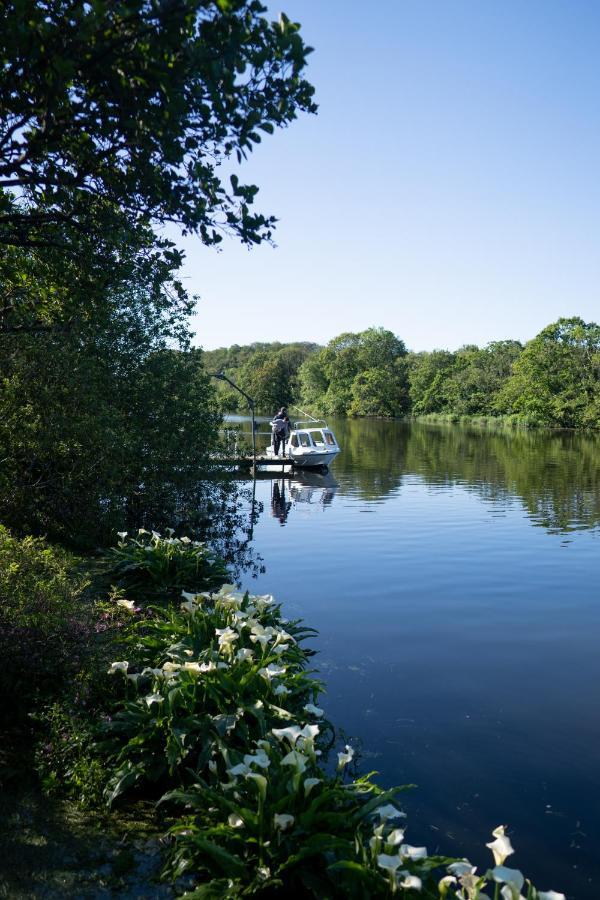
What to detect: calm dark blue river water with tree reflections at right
<box><xmin>232</xmin><ymin>421</ymin><xmax>600</xmax><ymax>900</ymax></box>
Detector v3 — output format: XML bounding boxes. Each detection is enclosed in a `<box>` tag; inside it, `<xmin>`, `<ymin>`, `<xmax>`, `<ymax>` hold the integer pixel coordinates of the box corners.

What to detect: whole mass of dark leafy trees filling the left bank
<box><xmin>0</xmin><ymin>0</ymin><xmax>316</xmax><ymax>540</ymax></box>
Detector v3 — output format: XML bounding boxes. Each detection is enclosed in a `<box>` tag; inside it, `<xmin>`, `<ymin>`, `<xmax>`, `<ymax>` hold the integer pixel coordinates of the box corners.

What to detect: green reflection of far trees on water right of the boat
<box><xmin>328</xmin><ymin>420</ymin><xmax>600</xmax><ymax>533</ymax></box>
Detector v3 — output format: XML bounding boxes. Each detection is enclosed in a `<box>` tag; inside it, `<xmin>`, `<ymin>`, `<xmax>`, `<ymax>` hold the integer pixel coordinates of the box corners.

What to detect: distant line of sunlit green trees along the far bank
<box><xmin>204</xmin><ymin>317</ymin><xmax>600</xmax><ymax>428</ymax></box>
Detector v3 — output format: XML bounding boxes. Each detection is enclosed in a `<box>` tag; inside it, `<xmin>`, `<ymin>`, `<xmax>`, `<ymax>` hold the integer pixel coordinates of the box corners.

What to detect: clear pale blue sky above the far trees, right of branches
<box><xmin>176</xmin><ymin>0</ymin><xmax>600</xmax><ymax>350</ymax></box>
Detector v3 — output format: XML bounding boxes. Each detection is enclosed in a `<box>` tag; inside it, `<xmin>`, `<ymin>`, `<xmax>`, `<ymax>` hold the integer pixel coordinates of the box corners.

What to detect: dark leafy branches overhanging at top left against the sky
<box><xmin>0</xmin><ymin>0</ymin><xmax>315</xmax><ymax>246</ymax></box>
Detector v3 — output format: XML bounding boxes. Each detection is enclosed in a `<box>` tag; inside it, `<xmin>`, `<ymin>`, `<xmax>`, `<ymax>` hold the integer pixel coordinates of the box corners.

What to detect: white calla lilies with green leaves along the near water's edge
<box><xmin>77</xmin><ymin>533</ymin><xmax>564</xmax><ymax>900</ymax></box>
